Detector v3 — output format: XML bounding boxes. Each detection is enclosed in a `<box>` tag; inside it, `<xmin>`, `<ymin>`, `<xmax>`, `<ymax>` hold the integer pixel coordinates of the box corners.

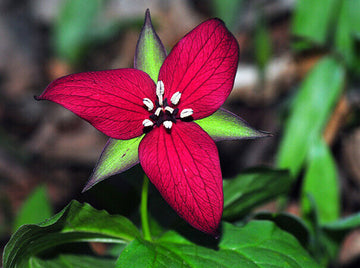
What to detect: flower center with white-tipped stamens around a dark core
<box><xmin>142</xmin><ymin>81</ymin><xmax>194</xmax><ymax>132</ymax></box>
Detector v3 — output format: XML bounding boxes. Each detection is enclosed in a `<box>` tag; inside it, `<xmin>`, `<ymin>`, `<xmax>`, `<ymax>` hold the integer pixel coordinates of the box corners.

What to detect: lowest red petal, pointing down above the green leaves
<box><xmin>139</xmin><ymin>122</ymin><xmax>223</xmax><ymax>235</ymax></box>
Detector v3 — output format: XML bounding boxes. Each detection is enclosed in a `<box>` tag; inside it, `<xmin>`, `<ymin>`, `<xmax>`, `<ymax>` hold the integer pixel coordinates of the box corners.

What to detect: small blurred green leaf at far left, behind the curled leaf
<box><xmin>13</xmin><ymin>186</ymin><xmax>52</xmax><ymax>231</ymax></box>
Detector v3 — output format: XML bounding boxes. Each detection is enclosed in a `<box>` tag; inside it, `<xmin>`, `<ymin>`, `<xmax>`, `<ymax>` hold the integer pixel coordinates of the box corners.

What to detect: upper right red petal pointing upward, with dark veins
<box><xmin>159</xmin><ymin>19</ymin><xmax>239</xmax><ymax>119</ymax></box>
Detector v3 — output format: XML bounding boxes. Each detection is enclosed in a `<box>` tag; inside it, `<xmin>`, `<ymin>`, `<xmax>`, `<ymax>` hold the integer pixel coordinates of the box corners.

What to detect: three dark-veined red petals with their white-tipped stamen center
<box><xmin>37</xmin><ymin>12</ymin><xmax>268</xmax><ymax>235</ymax></box>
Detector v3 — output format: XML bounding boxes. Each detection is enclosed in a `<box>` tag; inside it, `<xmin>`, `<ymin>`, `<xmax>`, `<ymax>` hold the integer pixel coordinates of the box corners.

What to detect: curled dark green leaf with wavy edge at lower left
<box><xmin>3</xmin><ymin>201</ymin><xmax>140</xmax><ymax>268</ymax></box>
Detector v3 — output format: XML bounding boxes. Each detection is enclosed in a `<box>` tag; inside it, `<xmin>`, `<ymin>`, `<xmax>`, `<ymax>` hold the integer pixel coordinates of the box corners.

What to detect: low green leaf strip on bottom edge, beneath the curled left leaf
<box><xmin>28</xmin><ymin>254</ymin><xmax>116</xmax><ymax>268</ymax></box>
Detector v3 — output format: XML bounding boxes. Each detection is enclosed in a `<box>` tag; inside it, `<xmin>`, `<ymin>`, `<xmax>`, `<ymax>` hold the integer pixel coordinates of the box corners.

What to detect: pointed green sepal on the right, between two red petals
<box><xmin>195</xmin><ymin>108</ymin><xmax>271</xmax><ymax>141</ymax></box>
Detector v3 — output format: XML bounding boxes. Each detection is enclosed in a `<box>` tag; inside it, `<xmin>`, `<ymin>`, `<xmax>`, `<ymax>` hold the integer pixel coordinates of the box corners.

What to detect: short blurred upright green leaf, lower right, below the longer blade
<box><xmin>301</xmin><ymin>138</ymin><xmax>340</xmax><ymax>224</ymax></box>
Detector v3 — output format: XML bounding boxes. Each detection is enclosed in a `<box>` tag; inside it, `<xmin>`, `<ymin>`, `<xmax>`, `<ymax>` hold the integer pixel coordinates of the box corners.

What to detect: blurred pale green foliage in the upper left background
<box><xmin>52</xmin><ymin>0</ymin><xmax>141</xmax><ymax>65</ymax></box>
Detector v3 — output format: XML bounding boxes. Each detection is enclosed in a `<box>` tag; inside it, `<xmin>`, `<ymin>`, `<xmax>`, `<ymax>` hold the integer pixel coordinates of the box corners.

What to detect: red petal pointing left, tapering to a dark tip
<box><xmin>37</xmin><ymin>69</ymin><xmax>156</xmax><ymax>140</ymax></box>
